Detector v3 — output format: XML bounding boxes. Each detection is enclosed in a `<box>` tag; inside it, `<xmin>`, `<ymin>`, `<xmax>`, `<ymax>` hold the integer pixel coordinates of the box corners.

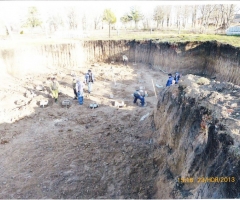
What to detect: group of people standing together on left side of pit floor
<box><xmin>50</xmin><ymin>70</ymin><xmax>94</xmax><ymax>105</ymax></box>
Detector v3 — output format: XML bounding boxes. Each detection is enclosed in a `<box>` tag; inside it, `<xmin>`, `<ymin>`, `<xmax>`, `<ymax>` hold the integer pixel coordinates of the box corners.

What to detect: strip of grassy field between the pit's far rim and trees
<box><xmin>0</xmin><ymin>30</ymin><xmax>240</xmax><ymax>47</ymax></box>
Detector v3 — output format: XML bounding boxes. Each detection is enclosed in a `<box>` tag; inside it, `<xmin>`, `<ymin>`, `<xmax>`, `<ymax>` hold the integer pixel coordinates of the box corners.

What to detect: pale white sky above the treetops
<box><xmin>0</xmin><ymin>0</ymin><xmax>240</xmax><ymax>24</ymax></box>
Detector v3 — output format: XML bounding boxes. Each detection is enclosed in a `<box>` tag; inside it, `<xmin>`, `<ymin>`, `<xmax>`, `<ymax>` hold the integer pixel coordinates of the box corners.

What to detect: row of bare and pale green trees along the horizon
<box><xmin>6</xmin><ymin>4</ymin><xmax>239</xmax><ymax>36</ymax></box>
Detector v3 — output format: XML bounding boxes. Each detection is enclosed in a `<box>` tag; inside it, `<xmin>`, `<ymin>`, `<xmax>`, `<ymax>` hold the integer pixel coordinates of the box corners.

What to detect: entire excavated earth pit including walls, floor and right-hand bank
<box><xmin>0</xmin><ymin>41</ymin><xmax>240</xmax><ymax>199</ymax></box>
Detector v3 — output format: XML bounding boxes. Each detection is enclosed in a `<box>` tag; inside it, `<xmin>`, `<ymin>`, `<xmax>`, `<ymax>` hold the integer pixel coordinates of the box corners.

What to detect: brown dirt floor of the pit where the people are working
<box><xmin>0</xmin><ymin>63</ymin><xmax>167</xmax><ymax>199</ymax></box>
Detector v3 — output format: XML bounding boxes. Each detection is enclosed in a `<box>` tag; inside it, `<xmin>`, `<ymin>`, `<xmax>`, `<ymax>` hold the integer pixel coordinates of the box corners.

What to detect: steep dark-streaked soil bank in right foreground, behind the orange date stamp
<box><xmin>153</xmin><ymin>75</ymin><xmax>240</xmax><ymax>199</ymax></box>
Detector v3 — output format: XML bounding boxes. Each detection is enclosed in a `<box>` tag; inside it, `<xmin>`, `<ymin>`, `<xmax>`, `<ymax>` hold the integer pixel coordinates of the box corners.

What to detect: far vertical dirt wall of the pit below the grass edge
<box><xmin>0</xmin><ymin>40</ymin><xmax>240</xmax><ymax>84</ymax></box>
